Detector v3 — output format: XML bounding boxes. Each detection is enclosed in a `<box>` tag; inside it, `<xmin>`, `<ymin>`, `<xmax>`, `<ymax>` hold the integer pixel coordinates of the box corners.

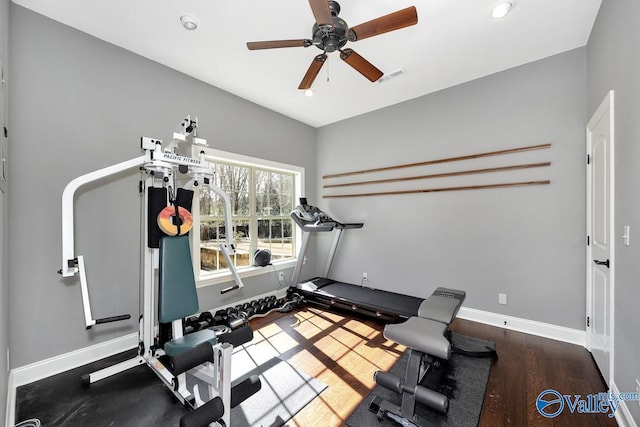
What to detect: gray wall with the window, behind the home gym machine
<box><xmin>8</xmin><ymin>5</ymin><xmax>316</xmax><ymax>367</ymax></box>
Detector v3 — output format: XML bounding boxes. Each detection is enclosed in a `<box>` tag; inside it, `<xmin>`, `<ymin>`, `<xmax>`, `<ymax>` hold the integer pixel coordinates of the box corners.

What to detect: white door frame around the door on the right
<box><xmin>585</xmin><ymin>90</ymin><xmax>616</xmax><ymax>387</ymax></box>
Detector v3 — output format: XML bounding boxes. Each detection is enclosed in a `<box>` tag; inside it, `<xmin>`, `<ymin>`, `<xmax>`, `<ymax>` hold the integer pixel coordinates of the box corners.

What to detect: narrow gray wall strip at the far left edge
<box><xmin>0</xmin><ymin>0</ymin><xmax>10</xmax><ymax>419</ymax></box>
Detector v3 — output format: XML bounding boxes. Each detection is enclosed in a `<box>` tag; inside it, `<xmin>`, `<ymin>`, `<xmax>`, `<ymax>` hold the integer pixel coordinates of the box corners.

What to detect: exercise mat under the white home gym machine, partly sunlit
<box><xmin>15</xmin><ymin>346</ymin><xmax>326</xmax><ymax>427</ymax></box>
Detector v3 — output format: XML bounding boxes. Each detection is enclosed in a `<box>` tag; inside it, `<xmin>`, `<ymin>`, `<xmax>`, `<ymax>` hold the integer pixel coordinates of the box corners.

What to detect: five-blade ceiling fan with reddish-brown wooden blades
<box><xmin>247</xmin><ymin>0</ymin><xmax>418</xmax><ymax>90</ymax></box>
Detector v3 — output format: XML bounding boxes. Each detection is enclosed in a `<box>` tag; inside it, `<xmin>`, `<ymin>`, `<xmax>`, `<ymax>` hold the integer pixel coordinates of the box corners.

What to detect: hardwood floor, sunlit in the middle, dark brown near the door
<box><xmin>251</xmin><ymin>308</ymin><xmax>617</xmax><ymax>427</ymax></box>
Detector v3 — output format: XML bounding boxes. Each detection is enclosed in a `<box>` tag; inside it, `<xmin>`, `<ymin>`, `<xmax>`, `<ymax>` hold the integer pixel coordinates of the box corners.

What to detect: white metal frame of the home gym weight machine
<box><xmin>58</xmin><ymin>116</ymin><xmax>244</xmax><ymax>426</ymax></box>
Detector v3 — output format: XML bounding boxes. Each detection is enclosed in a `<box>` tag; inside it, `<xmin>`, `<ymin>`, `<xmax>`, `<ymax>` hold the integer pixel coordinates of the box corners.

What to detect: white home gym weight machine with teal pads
<box><xmin>58</xmin><ymin>116</ymin><xmax>260</xmax><ymax>426</ymax></box>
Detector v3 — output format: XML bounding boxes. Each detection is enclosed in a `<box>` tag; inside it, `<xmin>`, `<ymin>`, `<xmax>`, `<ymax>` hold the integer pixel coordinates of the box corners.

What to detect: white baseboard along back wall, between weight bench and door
<box><xmin>458</xmin><ymin>307</ymin><xmax>586</xmax><ymax>347</ymax></box>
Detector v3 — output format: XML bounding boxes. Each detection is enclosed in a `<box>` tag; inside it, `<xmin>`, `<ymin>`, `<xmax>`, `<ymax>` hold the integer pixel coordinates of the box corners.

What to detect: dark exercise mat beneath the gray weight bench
<box><xmin>347</xmin><ymin>333</ymin><xmax>495</xmax><ymax>427</ymax></box>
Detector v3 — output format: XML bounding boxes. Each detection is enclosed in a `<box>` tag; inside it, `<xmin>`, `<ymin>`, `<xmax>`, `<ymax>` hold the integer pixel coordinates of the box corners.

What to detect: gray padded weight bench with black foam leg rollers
<box><xmin>369</xmin><ymin>288</ymin><xmax>495</xmax><ymax>427</ymax></box>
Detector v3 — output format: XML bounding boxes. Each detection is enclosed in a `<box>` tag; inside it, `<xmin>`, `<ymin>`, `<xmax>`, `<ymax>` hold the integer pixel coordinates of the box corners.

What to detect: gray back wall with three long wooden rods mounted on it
<box><xmin>317</xmin><ymin>48</ymin><xmax>586</xmax><ymax>329</ymax></box>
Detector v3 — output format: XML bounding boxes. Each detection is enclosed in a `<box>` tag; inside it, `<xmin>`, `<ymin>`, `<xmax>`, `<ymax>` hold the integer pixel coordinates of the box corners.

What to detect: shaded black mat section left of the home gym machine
<box><xmin>15</xmin><ymin>351</ymin><xmax>187</xmax><ymax>427</ymax></box>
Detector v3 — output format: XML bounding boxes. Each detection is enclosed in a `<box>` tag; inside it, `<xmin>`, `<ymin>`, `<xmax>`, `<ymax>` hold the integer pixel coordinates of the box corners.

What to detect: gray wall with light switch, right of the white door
<box><xmin>587</xmin><ymin>0</ymin><xmax>640</xmax><ymax>423</ymax></box>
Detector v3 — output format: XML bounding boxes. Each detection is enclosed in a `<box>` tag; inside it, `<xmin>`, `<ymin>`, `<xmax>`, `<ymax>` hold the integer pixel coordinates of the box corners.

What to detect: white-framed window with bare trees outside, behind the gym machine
<box><xmin>192</xmin><ymin>147</ymin><xmax>304</xmax><ymax>285</ymax></box>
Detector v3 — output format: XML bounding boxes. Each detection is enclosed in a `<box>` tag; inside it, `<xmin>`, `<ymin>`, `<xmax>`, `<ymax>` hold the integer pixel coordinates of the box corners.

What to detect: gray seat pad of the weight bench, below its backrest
<box><xmin>384</xmin><ymin>317</ymin><xmax>451</xmax><ymax>360</ymax></box>
